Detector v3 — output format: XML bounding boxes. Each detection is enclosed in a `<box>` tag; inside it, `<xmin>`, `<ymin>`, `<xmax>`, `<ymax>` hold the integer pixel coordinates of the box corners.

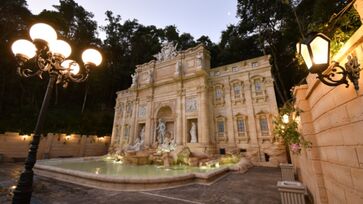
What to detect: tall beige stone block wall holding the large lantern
<box><xmin>292</xmin><ymin>0</ymin><xmax>363</xmax><ymax>204</ymax></box>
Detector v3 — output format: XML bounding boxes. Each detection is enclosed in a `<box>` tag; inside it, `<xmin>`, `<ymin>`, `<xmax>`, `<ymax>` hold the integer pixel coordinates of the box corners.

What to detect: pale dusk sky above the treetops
<box><xmin>27</xmin><ymin>0</ymin><xmax>238</xmax><ymax>43</ymax></box>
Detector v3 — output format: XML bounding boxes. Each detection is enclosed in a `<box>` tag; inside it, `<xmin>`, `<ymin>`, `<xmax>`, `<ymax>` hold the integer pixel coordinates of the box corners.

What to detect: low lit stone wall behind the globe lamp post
<box><xmin>0</xmin><ymin>132</ymin><xmax>111</xmax><ymax>161</ymax></box>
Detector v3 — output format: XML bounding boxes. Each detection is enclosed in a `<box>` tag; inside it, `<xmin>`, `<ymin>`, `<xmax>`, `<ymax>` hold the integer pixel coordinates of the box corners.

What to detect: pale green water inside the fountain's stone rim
<box><xmin>43</xmin><ymin>160</ymin><xmax>225</xmax><ymax>178</ymax></box>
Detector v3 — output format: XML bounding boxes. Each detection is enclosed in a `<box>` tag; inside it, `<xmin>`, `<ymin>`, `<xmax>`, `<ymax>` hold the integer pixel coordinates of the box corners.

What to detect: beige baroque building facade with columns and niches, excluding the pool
<box><xmin>111</xmin><ymin>43</ymin><xmax>286</xmax><ymax>164</ymax></box>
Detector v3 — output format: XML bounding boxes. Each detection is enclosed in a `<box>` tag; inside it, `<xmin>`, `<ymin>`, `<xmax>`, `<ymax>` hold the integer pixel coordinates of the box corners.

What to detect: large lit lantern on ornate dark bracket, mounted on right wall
<box><xmin>296</xmin><ymin>33</ymin><xmax>360</xmax><ymax>91</ymax></box>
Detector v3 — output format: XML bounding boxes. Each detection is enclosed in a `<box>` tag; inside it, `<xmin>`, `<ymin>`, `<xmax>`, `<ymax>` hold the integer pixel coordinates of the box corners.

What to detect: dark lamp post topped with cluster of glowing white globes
<box><xmin>11</xmin><ymin>23</ymin><xmax>102</xmax><ymax>204</ymax></box>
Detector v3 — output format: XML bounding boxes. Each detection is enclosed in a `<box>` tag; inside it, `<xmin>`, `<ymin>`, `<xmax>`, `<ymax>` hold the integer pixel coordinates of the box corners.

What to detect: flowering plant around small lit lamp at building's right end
<box><xmin>273</xmin><ymin>102</ymin><xmax>311</xmax><ymax>153</ymax></box>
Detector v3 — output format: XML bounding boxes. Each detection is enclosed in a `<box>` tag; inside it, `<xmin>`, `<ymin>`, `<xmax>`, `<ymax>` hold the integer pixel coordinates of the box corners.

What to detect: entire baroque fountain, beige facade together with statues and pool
<box><xmin>35</xmin><ymin>43</ymin><xmax>286</xmax><ymax>191</ymax></box>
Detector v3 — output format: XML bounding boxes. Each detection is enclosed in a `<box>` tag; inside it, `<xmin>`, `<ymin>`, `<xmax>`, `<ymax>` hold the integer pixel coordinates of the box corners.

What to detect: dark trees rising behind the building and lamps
<box><xmin>0</xmin><ymin>0</ymin><xmax>360</xmax><ymax>134</ymax></box>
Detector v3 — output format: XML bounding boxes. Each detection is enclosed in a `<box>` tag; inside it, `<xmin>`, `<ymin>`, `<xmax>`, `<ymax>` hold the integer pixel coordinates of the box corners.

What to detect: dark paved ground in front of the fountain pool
<box><xmin>0</xmin><ymin>163</ymin><xmax>281</xmax><ymax>204</ymax></box>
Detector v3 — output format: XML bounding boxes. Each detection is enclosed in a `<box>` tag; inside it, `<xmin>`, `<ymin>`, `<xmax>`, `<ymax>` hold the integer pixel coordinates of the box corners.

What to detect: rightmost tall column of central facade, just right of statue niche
<box><xmin>198</xmin><ymin>84</ymin><xmax>210</xmax><ymax>145</ymax></box>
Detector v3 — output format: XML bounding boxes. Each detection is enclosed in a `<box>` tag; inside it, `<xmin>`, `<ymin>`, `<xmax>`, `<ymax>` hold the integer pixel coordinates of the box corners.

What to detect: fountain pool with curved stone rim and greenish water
<box><xmin>34</xmin><ymin>157</ymin><xmax>235</xmax><ymax>191</ymax></box>
